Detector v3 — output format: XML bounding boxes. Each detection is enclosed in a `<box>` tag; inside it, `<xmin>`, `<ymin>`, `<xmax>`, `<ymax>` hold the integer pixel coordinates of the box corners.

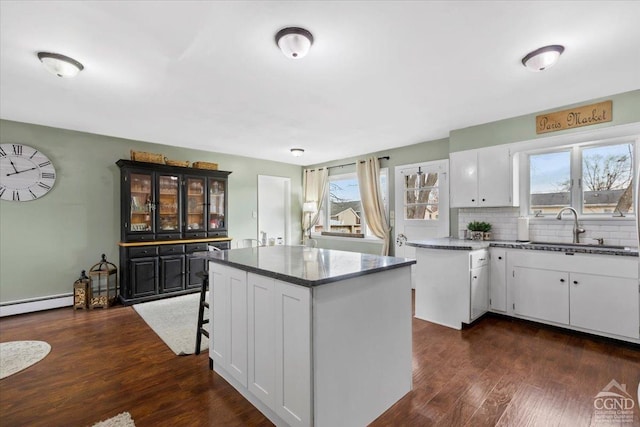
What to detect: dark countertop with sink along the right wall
<box><xmin>407</xmin><ymin>237</ymin><xmax>638</xmax><ymax>257</ymax></box>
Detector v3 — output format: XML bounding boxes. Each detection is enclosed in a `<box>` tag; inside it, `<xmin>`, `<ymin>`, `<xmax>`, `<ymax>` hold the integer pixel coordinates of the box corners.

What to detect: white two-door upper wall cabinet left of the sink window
<box><xmin>450</xmin><ymin>145</ymin><xmax>519</xmax><ymax>208</ymax></box>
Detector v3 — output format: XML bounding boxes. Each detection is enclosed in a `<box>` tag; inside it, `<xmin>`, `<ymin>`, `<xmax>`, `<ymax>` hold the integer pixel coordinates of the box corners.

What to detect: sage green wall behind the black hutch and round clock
<box><xmin>0</xmin><ymin>120</ymin><xmax>302</xmax><ymax>303</ymax></box>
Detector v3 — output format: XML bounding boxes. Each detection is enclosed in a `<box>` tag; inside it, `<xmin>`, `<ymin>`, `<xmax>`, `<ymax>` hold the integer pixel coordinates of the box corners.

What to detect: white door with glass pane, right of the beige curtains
<box><xmin>392</xmin><ymin>160</ymin><xmax>449</xmax><ymax>259</ymax></box>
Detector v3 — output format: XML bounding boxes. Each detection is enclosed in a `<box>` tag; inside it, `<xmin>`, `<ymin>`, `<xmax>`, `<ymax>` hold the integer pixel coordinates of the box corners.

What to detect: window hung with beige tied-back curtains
<box><xmin>312</xmin><ymin>168</ymin><xmax>389</xmax><ymax>237</ymax></box>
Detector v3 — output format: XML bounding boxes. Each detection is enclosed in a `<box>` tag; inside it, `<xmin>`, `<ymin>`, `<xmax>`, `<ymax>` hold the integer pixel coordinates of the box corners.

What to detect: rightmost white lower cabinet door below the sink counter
<box><xmin>569</xmin><ymin>273</ymin><xmax>640</xmax><ymax>338</ymax></box>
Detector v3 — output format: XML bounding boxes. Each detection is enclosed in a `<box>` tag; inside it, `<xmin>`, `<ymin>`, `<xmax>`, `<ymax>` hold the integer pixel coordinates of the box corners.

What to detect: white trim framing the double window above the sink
<box><xmin>511</xmin><ymin>123</ymin><xmax>640</xmax><ymax>217</ymax></box>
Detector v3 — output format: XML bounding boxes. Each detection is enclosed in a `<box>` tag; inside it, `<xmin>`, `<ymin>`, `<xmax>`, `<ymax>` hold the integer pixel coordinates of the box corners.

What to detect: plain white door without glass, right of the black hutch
<box><xmin>252</xmin><ymin>175</ymin><xmax>291</xmax><ymax>245</ymax></box>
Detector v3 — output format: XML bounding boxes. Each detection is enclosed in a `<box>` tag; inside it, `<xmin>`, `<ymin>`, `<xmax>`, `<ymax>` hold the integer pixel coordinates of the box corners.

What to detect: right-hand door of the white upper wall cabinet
<box><xmin>478</xmin><ymin>146</ymin><xmax>514</xmax><ymax>207</ymax></box>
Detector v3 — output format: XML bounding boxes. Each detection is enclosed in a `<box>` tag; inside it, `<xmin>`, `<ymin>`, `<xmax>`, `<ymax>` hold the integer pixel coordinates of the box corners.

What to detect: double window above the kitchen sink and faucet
<box><xmin>529</xmin><ymin>142</ymin><xmax>634</xmax><ymax>216</ymax></box>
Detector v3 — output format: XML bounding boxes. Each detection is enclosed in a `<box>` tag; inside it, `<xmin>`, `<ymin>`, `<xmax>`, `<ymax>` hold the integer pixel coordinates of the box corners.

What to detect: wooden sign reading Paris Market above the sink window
<box><xmin>536</xmin><ymin>101</ymin><xmax>613</xmax><ymax>134</ymax></box>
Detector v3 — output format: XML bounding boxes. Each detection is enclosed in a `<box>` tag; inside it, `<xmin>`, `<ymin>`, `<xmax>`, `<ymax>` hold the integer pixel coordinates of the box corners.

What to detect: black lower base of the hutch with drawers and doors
<box><xmin>119</xmin><ymin>239</ymin><xmax>230</xmax><ymax>305</ymax></box>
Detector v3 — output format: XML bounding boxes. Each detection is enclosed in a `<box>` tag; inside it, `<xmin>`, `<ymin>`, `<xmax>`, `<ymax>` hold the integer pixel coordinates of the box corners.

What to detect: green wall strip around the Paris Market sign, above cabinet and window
<box><xmin>449</xmin><ymin>90</ymin><xmax>640</xmax><ymax>152</ymax></box>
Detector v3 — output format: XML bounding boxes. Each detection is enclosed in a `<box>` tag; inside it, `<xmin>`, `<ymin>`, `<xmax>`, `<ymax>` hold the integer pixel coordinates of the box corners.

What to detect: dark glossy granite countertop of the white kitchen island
<box><xmin>196</xmin><ymin>245</ymin><xmax>416</xmax><ymax>287</ymax></box>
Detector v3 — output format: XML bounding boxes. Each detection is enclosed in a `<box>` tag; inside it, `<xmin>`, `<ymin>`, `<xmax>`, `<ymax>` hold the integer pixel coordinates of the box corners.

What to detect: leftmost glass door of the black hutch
<box><xmin>127</xmin><ymin>172</ymin><xmax>154</xmax><ymax>239</ymax></box>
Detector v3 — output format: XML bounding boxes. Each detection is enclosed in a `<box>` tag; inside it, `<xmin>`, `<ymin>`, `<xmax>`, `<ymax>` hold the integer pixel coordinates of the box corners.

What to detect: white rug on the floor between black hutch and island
<box><xmin>133</xmin><ymin>292</ymin><xmax>209</xmax><ymax>356</ymax></box>
